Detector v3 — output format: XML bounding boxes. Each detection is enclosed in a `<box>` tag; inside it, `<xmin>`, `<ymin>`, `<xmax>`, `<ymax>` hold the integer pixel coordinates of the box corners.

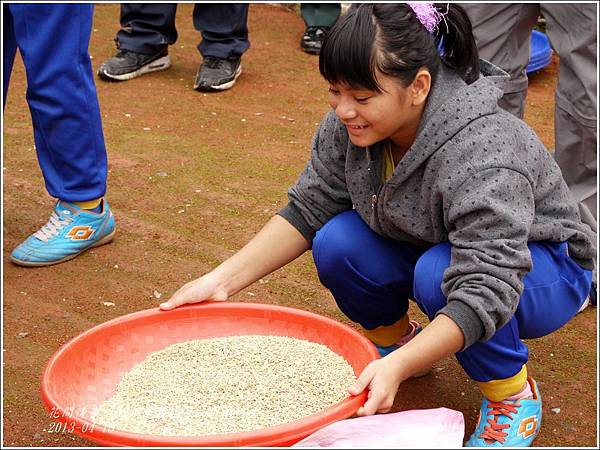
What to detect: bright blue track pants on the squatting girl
<box><xmin>313</xmin><ymin>211</ymin><xmax>592</xmax><ymax>382</ymax></box>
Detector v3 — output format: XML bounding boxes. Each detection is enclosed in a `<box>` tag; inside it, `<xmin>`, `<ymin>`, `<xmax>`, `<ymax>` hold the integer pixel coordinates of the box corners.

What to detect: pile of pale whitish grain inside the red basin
<box><xmin>92</xmin><ymin>335</ymin><xmax>356</xmax><ymax>436</ymax></box>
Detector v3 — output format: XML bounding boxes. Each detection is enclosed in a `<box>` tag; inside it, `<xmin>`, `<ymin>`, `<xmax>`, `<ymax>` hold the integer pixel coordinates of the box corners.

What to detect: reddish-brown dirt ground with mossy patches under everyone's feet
<box><xmin>2</xmin><ymin>4</ymin><xmax>598</xmax><ymax>447</ymax></box>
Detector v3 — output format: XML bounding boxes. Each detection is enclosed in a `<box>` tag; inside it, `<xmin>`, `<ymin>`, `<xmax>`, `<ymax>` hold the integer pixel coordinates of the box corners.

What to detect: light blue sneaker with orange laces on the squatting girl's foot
<box><xmin>465</xmin><ymin>377</ymin><xmax>542</xmax><ymax>447</ymax></box>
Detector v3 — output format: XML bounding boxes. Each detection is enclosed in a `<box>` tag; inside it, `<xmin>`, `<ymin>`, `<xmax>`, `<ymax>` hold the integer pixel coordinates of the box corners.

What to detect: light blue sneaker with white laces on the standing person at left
<box><xmin>10</xmin><ymin>199</ymin><xmax>115</xmax><ymax>267</ymax></box>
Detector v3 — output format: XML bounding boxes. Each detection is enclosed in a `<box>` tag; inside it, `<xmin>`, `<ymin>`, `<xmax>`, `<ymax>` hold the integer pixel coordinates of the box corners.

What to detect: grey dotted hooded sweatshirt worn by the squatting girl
<box><xmin>279</xmin><ymin>61</ymin><xmax>596</xmax><ymax>348</ymax></box>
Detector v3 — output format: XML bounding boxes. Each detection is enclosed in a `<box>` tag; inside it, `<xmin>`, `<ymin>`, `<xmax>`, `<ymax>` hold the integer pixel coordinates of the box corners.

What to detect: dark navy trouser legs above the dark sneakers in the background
<box><xmin>117</xmin><ymin>3</ymin><xmax>250</xmax><ymax>58</ymax></box>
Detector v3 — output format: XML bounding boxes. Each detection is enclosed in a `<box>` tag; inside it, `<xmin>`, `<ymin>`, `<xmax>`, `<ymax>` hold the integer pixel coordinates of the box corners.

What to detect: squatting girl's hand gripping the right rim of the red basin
<box><xmin>348</xmin><ymin>356</ymin><xmax>406</xmax><ymax>416</ymax></box>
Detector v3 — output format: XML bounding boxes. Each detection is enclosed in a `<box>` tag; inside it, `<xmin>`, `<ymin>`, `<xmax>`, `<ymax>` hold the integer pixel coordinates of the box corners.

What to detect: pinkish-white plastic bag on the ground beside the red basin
<box><xmin>293</xmin><ymin>408</ymin><xmax>465</xmax><ymax>448</ymax></box>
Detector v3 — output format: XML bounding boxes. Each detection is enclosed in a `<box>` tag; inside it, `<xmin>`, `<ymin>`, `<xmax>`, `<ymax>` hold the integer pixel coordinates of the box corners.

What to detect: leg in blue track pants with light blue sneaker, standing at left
<box><xmin>3</xmin><ymin>4</ymin><xmax>115</xmax><ymax>266</ymax></box>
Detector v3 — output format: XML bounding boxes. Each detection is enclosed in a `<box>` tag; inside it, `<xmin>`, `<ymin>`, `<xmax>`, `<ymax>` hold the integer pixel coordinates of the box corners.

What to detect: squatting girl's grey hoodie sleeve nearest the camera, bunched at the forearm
<box><xmin>438</xmin><ymin>168</ymin><xmax>535</xmax><ymax>348</ymax></box>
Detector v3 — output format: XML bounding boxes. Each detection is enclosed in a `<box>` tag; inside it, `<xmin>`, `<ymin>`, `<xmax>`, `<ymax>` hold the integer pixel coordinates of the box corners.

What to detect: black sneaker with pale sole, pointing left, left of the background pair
<box><xmin>98</xmin><ymin>47</ymin><xmax>171</xmax><ymax>81</ymax></box>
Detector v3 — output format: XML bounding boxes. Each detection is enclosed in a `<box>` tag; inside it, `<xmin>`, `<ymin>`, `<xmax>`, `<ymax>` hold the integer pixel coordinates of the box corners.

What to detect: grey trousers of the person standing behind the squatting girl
<box><xmin>461</xmin><ymin>3</ymin><xmax>597</xmax><ymax>310</ymax></box>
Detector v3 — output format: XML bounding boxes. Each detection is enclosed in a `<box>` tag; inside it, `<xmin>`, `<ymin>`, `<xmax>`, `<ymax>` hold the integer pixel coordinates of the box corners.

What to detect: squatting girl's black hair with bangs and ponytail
<box><xmin>319</xmin><ymin>3</ymin><xmax>479</xmax><ymax>92</ymax></box>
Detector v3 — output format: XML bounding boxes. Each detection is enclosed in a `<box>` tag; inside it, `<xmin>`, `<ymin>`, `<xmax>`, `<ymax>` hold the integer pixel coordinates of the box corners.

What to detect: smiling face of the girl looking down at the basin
<box><xmin>329</xmin><ymin>72</ymin><xmax>429</xmax><ymax>147</ymax></box>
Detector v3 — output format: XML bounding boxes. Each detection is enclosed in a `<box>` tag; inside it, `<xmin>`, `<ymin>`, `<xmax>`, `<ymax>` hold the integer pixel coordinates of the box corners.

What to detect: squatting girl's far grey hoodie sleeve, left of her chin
<box><xmin>278</xmin><ymin>111</ymin><xmax>352</xmax><ymax>243</ymax></box>
